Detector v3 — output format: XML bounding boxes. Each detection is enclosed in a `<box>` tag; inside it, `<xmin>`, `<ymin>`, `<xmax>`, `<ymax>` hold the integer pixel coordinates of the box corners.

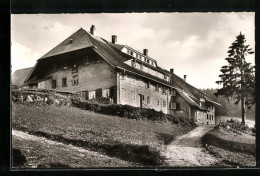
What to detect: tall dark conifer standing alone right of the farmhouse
<box><xmin>214</xmin><ymin>32</ymin><xmax>255</xmax><ymax>125</ymax></box>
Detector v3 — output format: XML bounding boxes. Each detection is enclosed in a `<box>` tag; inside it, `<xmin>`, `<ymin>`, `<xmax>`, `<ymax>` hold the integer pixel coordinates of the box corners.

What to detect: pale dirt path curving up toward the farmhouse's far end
<box><xmin>161</xmin><ymin>126</ymin><xmax>219</xmax><ymax>167</ymax></box>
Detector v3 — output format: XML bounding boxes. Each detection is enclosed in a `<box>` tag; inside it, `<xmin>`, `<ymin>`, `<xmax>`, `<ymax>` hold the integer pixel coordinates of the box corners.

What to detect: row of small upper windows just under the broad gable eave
<box><xmin>52</xmin><ymin>56</ymin><xmax>101</xmax><ymax>73</ymax></box>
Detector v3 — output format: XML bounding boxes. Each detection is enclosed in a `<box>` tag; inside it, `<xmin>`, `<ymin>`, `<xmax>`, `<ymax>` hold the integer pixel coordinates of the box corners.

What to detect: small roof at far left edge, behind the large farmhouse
<box><xmin>12</xmin><ymin>67</ymin><xmax>33</xmax><ymax>86</ymax></box>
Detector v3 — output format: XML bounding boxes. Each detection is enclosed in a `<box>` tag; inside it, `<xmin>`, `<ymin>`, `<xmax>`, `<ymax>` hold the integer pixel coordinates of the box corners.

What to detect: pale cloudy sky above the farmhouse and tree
<box><xmin>11</xmin><ymin>12</ymin><xmax>255</xmax><ymax>89</ymax></box>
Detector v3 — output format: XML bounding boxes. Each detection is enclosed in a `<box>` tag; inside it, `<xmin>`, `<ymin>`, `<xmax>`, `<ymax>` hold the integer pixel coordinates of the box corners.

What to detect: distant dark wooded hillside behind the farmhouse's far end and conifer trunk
<box><xmin>202</xmin><ymin>89</ymin><xmax>255</xmax><ymax>120</ymax></box>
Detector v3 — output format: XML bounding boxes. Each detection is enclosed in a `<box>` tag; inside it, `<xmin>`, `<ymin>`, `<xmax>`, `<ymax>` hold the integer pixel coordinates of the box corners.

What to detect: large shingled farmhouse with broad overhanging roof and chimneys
<box><xmin>14</xmin><ymin>25</ymin><xmax>218</xmax><ymax>124</ymax></box>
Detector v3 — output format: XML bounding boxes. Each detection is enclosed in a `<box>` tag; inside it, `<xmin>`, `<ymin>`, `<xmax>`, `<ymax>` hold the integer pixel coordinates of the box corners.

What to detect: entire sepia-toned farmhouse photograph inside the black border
<box><xmin>11</xmin><ymin>12</ymin><xmax>256</xmax><ymax>170</ymax></box>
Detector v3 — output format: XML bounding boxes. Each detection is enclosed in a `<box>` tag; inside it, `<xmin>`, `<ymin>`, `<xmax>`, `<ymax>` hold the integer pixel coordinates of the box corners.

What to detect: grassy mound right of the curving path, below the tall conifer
<box><xmin>202</xmin><ymin>128</ymin><xmax>256</xmax><ymax>167</ymax></box>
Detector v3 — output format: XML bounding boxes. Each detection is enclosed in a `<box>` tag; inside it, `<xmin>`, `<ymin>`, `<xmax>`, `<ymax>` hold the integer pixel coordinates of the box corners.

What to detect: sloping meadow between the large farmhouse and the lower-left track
<box><xmin>12</xmin><ymin>103</ymin><xmax>195</xmax><ymax>167</ymax></box>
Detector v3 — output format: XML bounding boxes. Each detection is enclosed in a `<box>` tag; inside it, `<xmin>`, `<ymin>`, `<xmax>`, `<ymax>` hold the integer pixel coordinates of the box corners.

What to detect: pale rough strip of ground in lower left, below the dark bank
<box><xmin>12</xmin><ymin>130</ymin><xmax>133</xmax><ymax>168</ymax></box>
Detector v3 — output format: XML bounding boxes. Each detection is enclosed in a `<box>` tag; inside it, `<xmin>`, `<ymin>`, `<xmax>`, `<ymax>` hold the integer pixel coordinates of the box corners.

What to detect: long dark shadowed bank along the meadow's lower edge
<box><xmin>13</xmin><ymin>126</ymin><xmax>163</xmax><ymax>166</ymax></box>
